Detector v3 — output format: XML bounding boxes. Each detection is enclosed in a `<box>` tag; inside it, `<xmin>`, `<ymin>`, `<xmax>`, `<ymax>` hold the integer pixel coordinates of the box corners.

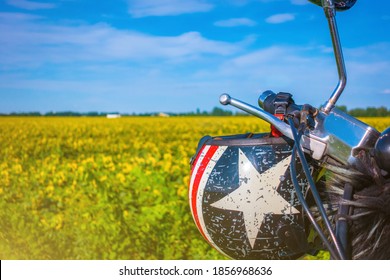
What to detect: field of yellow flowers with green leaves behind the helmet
<box><xmin>0</xmin><ymin>117</ymin><xmax>390</xmax><ymax>260</ymax></box>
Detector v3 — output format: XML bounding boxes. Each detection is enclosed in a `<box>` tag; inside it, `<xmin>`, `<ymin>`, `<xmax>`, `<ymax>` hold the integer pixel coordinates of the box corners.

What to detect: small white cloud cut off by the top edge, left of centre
<box><xmin>128</xmin><ymin>0</ymin><xmax>213</xmax><ymax>18</ymax></box>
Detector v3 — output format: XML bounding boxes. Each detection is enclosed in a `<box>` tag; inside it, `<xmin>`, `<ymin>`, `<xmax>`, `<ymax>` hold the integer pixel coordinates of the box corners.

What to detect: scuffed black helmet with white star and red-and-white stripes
<box><xmin>189</xmin><ymin>134</ymin><xmax>312</xmax><ymax>260</ymax></box>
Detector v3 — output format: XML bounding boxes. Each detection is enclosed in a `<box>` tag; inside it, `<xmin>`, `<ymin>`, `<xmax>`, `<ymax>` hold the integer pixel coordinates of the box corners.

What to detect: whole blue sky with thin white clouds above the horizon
<box><xmin>0</xmin><ymin>0</ymin><xmax>390</xmax><ymax>113</ymax></box>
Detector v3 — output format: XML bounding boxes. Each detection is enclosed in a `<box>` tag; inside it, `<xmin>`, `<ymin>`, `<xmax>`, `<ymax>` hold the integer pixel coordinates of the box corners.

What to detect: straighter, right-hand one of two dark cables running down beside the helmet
<box><xmin>288</xmin><ymin>118</ymin><xmax>345</xmax><ymax>259</ymax></box>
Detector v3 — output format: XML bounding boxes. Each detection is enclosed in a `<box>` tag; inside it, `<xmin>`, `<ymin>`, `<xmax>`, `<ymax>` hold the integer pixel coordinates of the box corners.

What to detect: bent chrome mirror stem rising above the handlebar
<box><xmin>322</xmin><ymin>0</ymin><xmax>347</xmax><ymax>114</ymax></box>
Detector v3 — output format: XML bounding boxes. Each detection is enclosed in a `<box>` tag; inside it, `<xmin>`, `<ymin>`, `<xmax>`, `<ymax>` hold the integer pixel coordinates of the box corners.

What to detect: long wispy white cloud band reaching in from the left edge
<box><xmin>0</xmin><ymin>14</ymin><xmax>242</xmax><ymax>67</ymax></box>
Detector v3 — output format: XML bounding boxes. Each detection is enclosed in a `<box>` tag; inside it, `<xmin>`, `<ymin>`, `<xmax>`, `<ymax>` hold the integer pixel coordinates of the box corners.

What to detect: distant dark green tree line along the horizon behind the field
<box><xmin>0</xmin><ymin>106</ymin><xmax>390</xmax><ymax>117</ymax></box>
